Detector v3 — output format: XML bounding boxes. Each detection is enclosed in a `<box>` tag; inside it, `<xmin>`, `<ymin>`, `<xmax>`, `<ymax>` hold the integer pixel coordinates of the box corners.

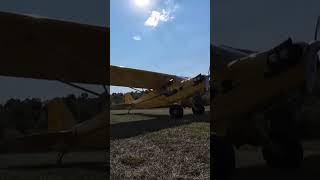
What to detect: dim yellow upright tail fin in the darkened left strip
<box><xmin>48</xmin><ymin>99</ymin><xmax>76</xmax><ymax>132</ymax></box>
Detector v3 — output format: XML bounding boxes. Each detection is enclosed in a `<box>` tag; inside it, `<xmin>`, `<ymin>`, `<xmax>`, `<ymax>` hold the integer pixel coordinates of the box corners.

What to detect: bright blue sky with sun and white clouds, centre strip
<box><xmin>110</xmin><ymin>0</ymin><xmax>210</xmax><ymax>92</ymax></box>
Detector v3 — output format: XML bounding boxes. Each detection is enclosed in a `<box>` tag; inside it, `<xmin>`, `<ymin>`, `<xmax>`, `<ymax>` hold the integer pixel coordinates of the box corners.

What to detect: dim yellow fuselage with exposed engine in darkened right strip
<box><xmin>212</xmin><ymin>39</ymin><xmax>306</xmax><ymax>144</ymax></box>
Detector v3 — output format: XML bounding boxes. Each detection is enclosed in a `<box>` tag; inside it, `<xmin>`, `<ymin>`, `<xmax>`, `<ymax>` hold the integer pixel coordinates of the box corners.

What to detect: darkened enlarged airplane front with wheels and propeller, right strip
<box><xmin>211</xmin><ymin>16</ymin><xmax>320</xmax><ymax>178</ymax></box>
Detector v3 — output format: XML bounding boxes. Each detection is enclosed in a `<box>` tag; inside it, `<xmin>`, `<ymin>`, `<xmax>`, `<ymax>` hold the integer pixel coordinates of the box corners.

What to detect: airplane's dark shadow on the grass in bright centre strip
<box><xmin>111</xmin><ymin>112</ymin><xmax>210</xmax><ymax>139</ymax></box>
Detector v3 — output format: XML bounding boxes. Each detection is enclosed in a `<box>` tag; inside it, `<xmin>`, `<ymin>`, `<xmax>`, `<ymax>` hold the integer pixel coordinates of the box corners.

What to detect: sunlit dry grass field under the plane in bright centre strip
<box><xmin>110</xmin><ymin>107</ymin><xmax>210</xmax><ymax>179</ymax></box>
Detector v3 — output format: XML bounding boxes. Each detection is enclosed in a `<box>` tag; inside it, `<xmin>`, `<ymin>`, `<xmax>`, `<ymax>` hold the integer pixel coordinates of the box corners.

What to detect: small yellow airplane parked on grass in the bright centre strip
<box><xmin>110</xmin><ymin>65</ymin><xmax>209</xmax><ymax>118</ymax></box>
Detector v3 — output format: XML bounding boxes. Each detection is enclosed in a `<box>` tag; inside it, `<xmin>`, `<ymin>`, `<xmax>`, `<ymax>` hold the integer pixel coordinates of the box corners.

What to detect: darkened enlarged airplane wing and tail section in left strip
<box><xmin>0</xmin><ymin>12</ymin><xmax>109</xmax><ymax>164</ymax></box>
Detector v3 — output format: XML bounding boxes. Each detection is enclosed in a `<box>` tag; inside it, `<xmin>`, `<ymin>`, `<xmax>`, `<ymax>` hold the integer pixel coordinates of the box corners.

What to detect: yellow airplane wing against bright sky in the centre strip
<box><xmin>110</xmin><ymin>65</ymin><xmax>184</xmax><ymax>89</ymax></box>
